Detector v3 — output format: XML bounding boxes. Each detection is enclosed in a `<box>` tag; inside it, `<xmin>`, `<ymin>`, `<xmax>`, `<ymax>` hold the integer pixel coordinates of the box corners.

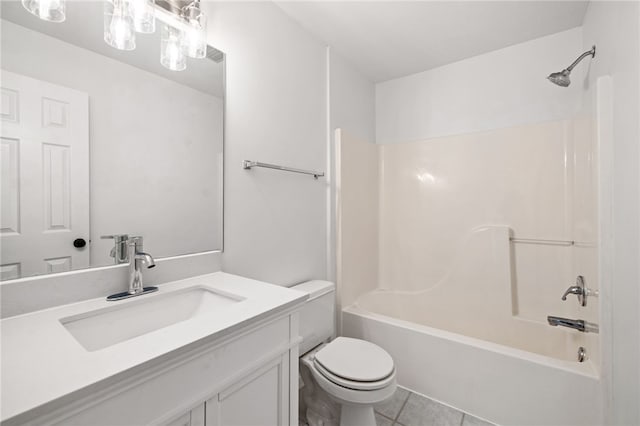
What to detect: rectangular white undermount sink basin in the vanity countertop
<box><xmin>60</xmin><ymin>287</ymin><xmax>244</xmax><ymax>352</ymax></box>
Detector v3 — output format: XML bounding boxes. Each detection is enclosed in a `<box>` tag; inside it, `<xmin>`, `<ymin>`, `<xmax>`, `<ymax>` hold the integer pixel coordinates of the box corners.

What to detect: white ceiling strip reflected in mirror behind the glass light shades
<box><xmin>0</xmin><ymin>0</ymin><xmax>224</xmax><ymax>97</ymax></box>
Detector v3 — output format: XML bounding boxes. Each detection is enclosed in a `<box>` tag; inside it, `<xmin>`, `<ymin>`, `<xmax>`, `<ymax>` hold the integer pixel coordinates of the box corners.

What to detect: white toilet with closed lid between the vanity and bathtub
<box><xmin>291</xmin><ymin>281</ymin><xmax>396</xmax><ymax>426</ymax></box>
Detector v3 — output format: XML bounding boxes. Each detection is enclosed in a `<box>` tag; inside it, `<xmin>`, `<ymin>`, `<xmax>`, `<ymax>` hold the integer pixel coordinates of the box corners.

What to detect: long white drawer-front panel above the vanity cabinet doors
<box><xmin>52</xmin><ymin>316</ymin><xmax>290</xmax><ymax>426</ymax></box>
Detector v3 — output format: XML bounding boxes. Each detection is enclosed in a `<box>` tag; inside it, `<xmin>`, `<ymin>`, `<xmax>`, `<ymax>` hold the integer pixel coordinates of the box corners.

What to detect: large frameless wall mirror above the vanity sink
<box><xmin>0</xmin><ymin>0</ymin><xmax>225</xmax><ymax>280</ymax></box>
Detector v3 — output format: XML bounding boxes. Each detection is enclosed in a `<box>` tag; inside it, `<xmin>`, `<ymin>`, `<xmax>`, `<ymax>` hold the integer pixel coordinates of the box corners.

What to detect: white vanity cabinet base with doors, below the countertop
<box><xmin>28</xmin><ymin>311</ymin><xmax>299</xmax><ymax>426</ymax></box>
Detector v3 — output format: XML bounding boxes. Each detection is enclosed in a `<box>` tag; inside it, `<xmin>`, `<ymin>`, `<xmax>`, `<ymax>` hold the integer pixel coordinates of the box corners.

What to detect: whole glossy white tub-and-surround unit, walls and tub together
<box><xmin>337</xmin><ymin>119</ymin><xmax>602</xmax><ymax>425</ymax></box>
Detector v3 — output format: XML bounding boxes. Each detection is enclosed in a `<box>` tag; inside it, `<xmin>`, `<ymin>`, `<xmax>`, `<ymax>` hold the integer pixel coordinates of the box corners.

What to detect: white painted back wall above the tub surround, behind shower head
<box><xmin>376</xmin><ymin>28</ymin><xmax>583</xmax><ymax>143</ymax></box>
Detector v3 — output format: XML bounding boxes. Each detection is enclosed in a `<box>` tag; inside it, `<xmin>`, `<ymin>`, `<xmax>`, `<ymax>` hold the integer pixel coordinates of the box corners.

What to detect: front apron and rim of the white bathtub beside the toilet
<box><xmin>342</xmin><ymin>305</ymin><xmax>603</xmax><ymax>426</ymax></box>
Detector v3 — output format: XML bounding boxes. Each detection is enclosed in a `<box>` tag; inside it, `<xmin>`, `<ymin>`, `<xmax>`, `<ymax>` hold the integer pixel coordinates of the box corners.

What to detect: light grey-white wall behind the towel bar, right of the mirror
<box><xmin>204</xmin><ymin>2</ymin><xmax>327</xmax><ymax>285</ymax></box>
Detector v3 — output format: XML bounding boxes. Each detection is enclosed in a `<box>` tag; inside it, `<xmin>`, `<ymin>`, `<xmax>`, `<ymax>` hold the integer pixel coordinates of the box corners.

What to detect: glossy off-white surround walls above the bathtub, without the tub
<box><xmin>336</xmin><ymin>120</ymin><xmax>598</xmax><ymax>328</ymax></box>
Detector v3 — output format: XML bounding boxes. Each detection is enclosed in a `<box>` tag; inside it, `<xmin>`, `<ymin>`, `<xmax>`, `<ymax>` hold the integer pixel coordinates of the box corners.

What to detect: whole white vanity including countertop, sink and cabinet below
<box><xmin>0</xmin><ymin>272</ymin><xmax>307</xmax><ymax>426</ymax></box>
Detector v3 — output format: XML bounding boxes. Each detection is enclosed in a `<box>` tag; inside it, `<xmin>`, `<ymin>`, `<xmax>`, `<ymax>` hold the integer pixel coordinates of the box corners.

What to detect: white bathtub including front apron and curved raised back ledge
<box><xmin>342</xmin><ymin>226</ymin><xmax>602</xmax><ymax>426</ymax></box>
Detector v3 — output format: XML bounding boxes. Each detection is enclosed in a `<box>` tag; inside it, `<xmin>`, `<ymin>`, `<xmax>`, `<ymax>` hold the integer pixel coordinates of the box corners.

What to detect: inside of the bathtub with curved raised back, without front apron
<box><xmin>354</xmin><ymin>226</ymin><xmax>599</xmax><ymax>360</ymax></box>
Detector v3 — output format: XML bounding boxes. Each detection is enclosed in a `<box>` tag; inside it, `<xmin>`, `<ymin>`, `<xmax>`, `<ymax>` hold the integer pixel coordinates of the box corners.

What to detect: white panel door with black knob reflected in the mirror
<box><xmin>0</xmin><ymin>70</ymin><xmax>89</xmax><ymax>280</ymax></box>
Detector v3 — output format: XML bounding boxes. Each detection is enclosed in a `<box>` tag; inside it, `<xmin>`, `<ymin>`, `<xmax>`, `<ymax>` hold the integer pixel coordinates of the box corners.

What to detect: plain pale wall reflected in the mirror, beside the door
<box><xmin>2</xmin><ymin>21</ymin><xmax>223</xmax><ymax>266</ymax></box>
